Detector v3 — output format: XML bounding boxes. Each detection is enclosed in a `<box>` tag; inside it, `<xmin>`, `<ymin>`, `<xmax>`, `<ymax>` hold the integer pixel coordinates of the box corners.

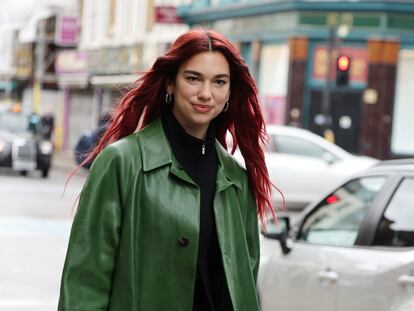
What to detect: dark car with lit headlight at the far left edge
<box><xmin>0</xmin><ymin>109</ymin><xmax>53</xmax><ymax>178</ymax></box>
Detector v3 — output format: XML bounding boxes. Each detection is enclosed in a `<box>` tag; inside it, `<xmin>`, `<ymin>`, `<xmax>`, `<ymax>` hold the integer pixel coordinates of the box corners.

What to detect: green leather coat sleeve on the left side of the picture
<box><xmin>58</xmin><ymin>146</ymin><xmax>122</xmax><ymax>311</ymax></box>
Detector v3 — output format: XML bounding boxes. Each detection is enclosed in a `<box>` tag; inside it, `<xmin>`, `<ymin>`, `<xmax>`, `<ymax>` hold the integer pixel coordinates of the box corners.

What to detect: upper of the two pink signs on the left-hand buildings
<box><xmin>55</xmin><ymin>15</ymin><xmax>79</xmax><ymax>46</ymax></box>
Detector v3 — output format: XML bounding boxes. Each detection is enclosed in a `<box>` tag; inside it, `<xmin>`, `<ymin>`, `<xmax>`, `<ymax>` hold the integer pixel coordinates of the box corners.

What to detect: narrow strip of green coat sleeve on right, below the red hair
<box><xmin>244</xmin><ymin>176</ymin><xmax>260</xmax><ymax>284</ymax></box>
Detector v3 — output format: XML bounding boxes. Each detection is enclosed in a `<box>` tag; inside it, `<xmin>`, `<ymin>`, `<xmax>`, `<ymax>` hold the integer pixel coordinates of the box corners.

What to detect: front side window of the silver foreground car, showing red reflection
<box><xmin>298</xmin><ymin>177</ymin><xmax>386</xmax><ymax>246</ymax></box>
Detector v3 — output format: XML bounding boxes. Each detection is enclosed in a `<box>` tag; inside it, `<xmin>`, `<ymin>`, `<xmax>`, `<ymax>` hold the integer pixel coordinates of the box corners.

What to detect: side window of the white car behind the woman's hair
<box><xmin>270</xmin><ymin>135</ymin><xmax>337</xmax><ymax>159</ymax></box>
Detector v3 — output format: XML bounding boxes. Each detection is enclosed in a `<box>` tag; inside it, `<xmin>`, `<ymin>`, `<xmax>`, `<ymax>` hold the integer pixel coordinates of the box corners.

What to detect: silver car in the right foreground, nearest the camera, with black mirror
<box><xmin>258</xmin><ymin>159</ymin><xmax>414</xmax><ymax>311</ymax></box>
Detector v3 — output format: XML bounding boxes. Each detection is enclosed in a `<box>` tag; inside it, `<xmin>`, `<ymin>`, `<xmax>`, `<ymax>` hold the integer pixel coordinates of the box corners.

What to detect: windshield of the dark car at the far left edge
<box><xmin>0</xmin><ymin>113</ymin><xmax>40</xmax><ymax>134</ymax></box>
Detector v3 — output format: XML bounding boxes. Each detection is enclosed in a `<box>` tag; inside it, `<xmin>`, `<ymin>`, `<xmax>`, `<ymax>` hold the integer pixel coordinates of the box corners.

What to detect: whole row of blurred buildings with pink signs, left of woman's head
<box><xmin>0</xmin><ymin>0</ymin><xmax>188</xmax><ymax>150</ymax></box>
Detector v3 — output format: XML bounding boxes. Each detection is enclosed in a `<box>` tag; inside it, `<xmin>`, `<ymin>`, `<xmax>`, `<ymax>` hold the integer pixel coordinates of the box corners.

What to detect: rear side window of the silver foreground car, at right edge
<box><xmin>374</xmin><ymin>178</ymin><xmax>414</xmax><ymax>247</ymax></box>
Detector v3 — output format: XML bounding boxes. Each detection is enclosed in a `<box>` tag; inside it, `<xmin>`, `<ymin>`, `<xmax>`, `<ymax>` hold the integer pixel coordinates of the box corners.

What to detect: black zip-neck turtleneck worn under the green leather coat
<box><xmin>162</xmin><ymin>111</ymin><xmax>232</xmax><ymax>311</ymax></box>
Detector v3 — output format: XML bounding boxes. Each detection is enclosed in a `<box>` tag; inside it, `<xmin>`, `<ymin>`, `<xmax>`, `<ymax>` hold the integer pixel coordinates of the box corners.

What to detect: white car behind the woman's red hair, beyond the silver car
<box><xmin>235</xmin><ymin>125</ymin><xmax>378</xmax><ymax>210</ymax></box>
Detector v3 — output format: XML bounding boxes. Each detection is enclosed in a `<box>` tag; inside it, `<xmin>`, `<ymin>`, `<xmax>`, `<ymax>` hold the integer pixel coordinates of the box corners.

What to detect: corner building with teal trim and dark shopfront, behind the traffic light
<box><xmin>179</xmin><ymin>0</ymin><xmax>414</xmax><ymax>159</ymax></box>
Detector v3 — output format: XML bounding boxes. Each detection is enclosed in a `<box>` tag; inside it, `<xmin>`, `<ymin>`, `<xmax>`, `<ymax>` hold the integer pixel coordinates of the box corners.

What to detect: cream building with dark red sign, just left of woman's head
<box><xmin>79</xmin><ymin>0</ymin><xmax>188</xmax><ymax>125</ymax></box>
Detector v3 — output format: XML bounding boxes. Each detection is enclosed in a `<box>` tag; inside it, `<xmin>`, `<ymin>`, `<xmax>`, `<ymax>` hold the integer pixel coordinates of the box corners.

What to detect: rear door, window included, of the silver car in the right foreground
<box><xmin>331</xmin><ymin>176</ymin><xmax>414</xmax><ymax>311</ymax></box>
